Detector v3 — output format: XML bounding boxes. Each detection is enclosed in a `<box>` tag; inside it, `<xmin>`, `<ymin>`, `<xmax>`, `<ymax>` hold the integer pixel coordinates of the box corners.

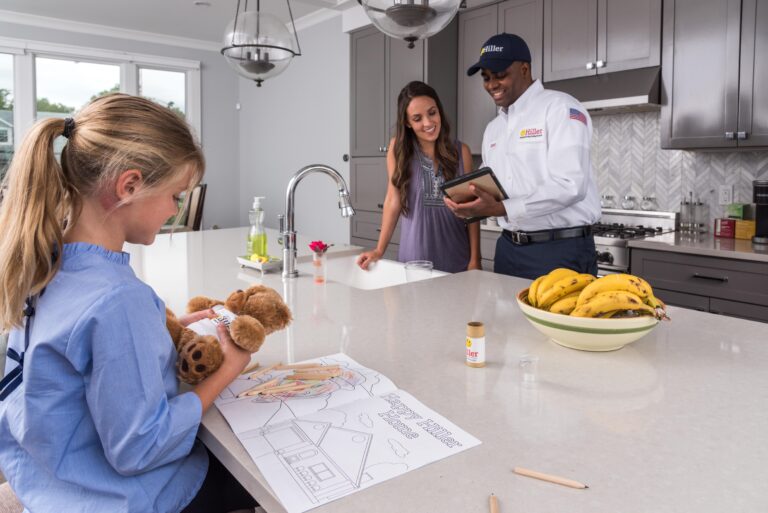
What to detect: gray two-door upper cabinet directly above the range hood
<box><xmin>544</xmin><ymin>0</ymin><xmax>661</xmax><ymax>82</ymax></box>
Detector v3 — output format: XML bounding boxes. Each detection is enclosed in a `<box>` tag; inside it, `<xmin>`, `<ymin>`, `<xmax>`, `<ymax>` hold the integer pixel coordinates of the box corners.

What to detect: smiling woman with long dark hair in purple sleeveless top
<box><xmin>357</xmin><ymin>82</ymin><xmax>480</xmax><ymax>273</ymax></box>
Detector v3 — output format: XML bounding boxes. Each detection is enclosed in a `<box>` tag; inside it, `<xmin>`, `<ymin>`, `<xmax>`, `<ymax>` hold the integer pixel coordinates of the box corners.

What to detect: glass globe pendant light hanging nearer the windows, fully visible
<box><xmin>221</xmin><ymin>0</ymin><xmax>301</xmax><ymax>87</ymax></box>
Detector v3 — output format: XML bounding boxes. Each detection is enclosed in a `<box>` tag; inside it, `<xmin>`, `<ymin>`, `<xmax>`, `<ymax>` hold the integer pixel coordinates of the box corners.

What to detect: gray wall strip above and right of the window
<box><xmin>0</xmin><ymin>22</ymin><xmax>241</xmax><ymax>228</ymax></box>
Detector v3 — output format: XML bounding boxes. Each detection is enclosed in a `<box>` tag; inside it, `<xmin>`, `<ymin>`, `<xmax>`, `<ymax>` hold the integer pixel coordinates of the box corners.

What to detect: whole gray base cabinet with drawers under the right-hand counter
<box><xmin>630</xmin><ymin>249</ymin><xmax>768</xmax><ymax>322</ymax></box>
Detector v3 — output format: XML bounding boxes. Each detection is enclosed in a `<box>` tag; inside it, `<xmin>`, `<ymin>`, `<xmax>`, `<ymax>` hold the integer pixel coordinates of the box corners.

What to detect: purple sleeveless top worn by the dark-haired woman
<box><xmin>397</xmin><ymin>143</ymin><xmax>470</xmax><ymax>273</ymax></box>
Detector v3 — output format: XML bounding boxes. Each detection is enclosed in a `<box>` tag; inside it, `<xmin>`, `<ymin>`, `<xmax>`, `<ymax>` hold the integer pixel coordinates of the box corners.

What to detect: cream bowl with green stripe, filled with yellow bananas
<box><xmin>517</xmin><ymin>268</ymin><xmax>669</xmax><ymax>351</ymax></box>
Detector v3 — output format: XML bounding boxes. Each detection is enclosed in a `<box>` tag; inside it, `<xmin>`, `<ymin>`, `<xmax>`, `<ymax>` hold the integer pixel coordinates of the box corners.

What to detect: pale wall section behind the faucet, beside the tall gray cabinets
<box><xmin>238</xmin><ymin>15</ymin><xmax>350</xmax><ymax>245</ymax></box>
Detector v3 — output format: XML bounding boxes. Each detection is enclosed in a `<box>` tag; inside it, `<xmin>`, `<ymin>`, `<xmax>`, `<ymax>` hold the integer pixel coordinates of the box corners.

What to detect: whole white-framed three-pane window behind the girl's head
<box><xmin>0</xmin><ymin>37</ymin><xmax>201</xmax><ymax>162</ymax></box>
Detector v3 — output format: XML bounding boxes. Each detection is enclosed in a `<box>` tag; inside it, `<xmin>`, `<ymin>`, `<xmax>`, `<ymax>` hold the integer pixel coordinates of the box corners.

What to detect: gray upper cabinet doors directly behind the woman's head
<box><xmin>350</xmin><ymin>23</ymin><xmax>457</xmax><ymax>157</ymax></box>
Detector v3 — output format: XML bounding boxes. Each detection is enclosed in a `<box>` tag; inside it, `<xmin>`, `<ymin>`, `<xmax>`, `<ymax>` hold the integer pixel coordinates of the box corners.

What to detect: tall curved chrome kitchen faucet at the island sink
<box><xmin>278</xmin><ymin>164</ymin><xmax>355</xmax><ymax>278</ymax></box>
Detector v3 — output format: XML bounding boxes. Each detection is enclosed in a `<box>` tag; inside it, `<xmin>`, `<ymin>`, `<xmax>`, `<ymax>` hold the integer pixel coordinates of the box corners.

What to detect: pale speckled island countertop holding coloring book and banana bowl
<box><xmin>127</xmin><ymin>228</ymin><xmax>768</xmax><ymax>513</ymax></box>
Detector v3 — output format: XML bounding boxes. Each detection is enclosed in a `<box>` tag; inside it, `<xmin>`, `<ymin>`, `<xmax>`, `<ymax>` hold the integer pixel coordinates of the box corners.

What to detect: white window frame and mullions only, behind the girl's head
<box><xmin>0</xmin><ymin>37</ymin><xmax>203</xmax><ymax>151</ymax></box>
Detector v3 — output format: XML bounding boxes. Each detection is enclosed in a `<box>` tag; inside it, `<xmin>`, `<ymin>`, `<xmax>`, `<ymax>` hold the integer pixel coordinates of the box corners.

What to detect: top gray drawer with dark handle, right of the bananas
<box><xmin>631</xmin><ymin>249</ymin><xmax>768</xmax><ymax>306</ymax></box>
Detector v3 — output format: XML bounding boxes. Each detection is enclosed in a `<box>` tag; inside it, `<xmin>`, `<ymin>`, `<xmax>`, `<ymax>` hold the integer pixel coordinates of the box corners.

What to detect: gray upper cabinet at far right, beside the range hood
<box><xmin>661</xmin><ymin>0</ymin><xmax>768</xmax><ymax>149</ymax></box>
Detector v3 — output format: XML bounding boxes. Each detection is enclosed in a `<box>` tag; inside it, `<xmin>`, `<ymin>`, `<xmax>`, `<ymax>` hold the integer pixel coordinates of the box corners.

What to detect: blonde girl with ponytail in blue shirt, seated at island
<box><xmin>0</xmin><ymin>94</ymin><xmax>254</xmax><ymax>513</ymax></box>
